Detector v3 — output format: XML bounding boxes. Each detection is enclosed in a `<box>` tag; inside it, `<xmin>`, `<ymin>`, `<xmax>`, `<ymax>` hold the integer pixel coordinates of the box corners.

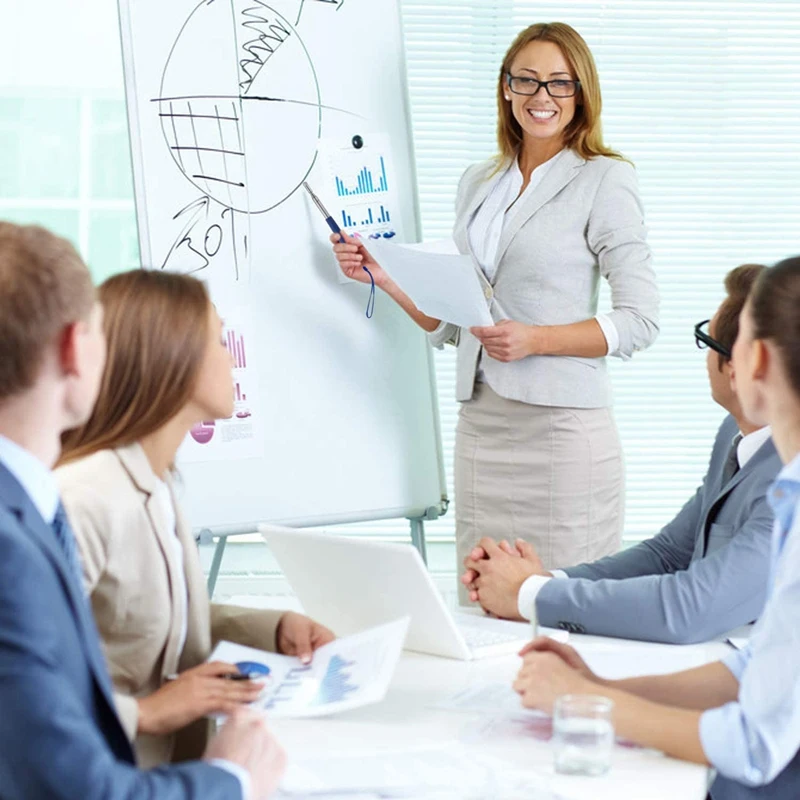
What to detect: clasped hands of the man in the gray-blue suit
<box><xmin>461</xmin><ymin>536</ymin><xmax>550</xmax><ymax>620</ymax></box>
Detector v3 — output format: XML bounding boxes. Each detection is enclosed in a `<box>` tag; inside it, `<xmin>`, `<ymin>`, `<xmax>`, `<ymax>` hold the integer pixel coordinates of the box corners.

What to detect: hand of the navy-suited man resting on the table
<box><xmin>203</xmin><ymin>709</ymin><xmax>286</xmax><ymax>800</ymax></box>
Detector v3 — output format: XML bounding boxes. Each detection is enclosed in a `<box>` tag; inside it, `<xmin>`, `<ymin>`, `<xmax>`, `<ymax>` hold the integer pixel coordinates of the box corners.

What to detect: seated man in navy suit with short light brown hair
<box><xmin>0</xmin><ymin>222</ymin><xmax>284</xmax><ymax>800</ymax></box>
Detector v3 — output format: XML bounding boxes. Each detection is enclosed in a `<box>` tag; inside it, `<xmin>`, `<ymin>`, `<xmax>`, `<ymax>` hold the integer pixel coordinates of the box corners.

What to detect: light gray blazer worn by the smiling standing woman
<box><xmin>430</xmin><ymin>150</ymin><xmax>658</xmax><ymax>408</ymax></box>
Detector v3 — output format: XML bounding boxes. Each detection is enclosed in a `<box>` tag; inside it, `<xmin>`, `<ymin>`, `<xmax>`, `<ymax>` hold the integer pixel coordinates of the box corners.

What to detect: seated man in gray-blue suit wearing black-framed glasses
<box><xmin>461</xmin><ymin>264</ymin><xmax>780</xmax><ymax>644</ymax></box>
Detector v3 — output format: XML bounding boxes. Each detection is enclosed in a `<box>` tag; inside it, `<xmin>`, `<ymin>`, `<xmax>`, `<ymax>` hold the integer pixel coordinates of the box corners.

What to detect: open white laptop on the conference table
<box><xmin>260</xmin><ymin>525</ymin><xmax>533</xmax><ymax>660</ymax></box>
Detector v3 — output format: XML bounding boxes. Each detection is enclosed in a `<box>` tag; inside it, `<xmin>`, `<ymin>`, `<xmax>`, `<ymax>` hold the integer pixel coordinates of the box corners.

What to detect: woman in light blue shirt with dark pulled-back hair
<box><xmin>514</xmin><ymin>257</ymin><xmax>800</xmax><ymax>800</ymax></box>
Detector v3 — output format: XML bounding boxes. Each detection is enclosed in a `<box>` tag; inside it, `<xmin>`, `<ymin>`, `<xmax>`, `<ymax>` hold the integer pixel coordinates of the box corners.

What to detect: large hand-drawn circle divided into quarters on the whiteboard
<box><xmin>155</xmin><ymin>0</ymin><xmax>322</xmax><ymax>214</ymax></box>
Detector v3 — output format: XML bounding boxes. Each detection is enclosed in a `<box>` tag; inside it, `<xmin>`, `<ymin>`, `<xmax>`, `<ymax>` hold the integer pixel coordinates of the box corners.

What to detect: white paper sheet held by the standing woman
<box><xmin>364</xmin><ymin>240</ymin><xmax>494</xmax><ymax>328</ymax></box>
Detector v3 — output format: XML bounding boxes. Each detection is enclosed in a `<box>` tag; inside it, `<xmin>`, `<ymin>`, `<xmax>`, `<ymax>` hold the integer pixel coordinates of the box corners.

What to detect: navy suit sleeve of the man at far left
<box><xmin>0</xmin><ymin>533</ymin><xmax>242</xmax><ymax>800</ymax></box>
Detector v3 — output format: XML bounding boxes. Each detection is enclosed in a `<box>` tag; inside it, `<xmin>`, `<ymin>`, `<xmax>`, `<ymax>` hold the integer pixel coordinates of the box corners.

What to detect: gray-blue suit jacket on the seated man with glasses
<box><xmin>536</xmin><ymin>416</ymin><xmax>781</xmax><ymax>644</ymax></box>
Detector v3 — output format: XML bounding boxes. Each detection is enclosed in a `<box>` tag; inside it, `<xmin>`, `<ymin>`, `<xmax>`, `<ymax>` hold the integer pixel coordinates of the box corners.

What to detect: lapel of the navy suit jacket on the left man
<box><xmin>0</xmin><ymin>464</ymin><xmax>116</xmax><ymax>713</ymax></box>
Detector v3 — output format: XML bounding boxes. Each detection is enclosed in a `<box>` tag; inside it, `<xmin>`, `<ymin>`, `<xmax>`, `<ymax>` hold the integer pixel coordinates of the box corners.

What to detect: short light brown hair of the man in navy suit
<box><xmin>0</xmin><ymin>222</ymin><xmax>95</xmax><ymax>402</ymax></box>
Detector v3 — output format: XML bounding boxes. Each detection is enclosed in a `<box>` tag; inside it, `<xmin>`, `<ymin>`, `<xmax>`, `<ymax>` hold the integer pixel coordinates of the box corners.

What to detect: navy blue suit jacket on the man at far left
<box><xmin>0</xmin><ymin>464</ymin><xmax>241</xmax><ymax>800</ymax></box>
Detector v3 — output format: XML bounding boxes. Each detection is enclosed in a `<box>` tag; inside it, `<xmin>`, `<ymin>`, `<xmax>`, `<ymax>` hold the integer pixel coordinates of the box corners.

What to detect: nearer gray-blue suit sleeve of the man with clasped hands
<box><xmin>536</xmin><ymin>496</ymin><xmax>773</xmax><ymax>644</ymax></box>
